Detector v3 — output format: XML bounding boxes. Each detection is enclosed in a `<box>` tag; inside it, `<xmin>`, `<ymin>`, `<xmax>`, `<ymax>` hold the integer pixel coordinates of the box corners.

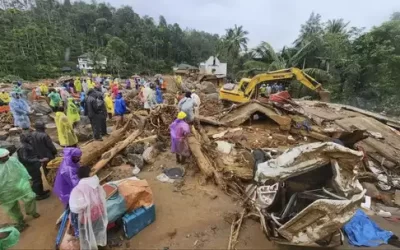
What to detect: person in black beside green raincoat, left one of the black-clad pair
<box><xmin>17</xmin><ymin>132</ymin><xmax>50</xmax><ymax>200</ymax></box>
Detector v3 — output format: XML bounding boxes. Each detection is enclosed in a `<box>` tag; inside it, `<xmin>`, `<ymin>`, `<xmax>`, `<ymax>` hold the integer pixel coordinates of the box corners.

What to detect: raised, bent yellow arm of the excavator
<box><xmin>244</xmin><ymin>68</ymin><xmax>323</xmax><ymax>96</ymax></box>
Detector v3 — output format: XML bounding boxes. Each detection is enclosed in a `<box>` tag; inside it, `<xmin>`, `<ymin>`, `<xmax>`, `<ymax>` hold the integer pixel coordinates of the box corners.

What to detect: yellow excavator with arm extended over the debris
<box><xmin>219</xmin><ymin>68</ymin><xmax>330</xmax><ymax>103</ymax></box>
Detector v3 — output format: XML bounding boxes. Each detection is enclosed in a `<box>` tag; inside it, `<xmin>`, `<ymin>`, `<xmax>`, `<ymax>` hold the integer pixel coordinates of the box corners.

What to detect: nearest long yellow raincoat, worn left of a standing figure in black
<box><xmin>55</xmin><ymin>112</ymin><xmax>78</xmax><ymax>147</ymax></box>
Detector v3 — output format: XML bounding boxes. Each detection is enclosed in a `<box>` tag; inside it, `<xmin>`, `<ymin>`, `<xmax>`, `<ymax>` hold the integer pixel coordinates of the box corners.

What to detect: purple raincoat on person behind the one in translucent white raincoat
<box><xmin>53</xmin><ymin>147</ymin><xmax>82</xmax><ymax>206</ymax></box>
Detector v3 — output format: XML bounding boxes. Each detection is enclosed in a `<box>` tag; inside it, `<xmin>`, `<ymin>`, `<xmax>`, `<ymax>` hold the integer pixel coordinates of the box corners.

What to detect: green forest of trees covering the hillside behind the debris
<box><xmin>0</xmin><ymin>0</ymin><xmax>400</xmax><ymax>115</ymax></box>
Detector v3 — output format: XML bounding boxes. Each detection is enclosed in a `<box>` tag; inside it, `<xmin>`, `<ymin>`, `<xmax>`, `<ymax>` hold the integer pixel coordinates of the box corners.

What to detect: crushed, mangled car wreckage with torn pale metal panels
<box><xmin>246</xmin><ymin>142</ymin><xmax>366</xmax><ymax>247</ymax></box>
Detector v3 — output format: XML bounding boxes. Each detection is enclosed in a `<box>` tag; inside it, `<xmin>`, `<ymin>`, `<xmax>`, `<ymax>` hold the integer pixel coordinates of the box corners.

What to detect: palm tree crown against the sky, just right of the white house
<box><xmin>223</xmin><ymin>24</ymin><xmax>249</xmax><ymax>57</ymax></box>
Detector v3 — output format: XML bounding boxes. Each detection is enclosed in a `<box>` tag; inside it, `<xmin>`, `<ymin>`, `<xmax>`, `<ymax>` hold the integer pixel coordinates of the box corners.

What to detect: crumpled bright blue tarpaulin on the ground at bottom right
<box><xmin>343</xmin><ymin>209</ymin><xmax>393</xmax><ymax>247</ymax></box>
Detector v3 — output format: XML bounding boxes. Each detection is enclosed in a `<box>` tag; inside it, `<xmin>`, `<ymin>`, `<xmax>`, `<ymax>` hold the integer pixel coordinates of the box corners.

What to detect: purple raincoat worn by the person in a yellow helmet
<box><xmin>169</xmin><ymin>119</ymin><xmax>190</xmax><ymax>156</ymax></box>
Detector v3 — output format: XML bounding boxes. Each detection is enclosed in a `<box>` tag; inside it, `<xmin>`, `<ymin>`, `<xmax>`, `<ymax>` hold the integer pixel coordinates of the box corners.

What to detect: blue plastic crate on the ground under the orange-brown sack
<box><xmin>122</xmin><ymin>205</ymin><xmax>156</xmax><ymax>239</ymax></box>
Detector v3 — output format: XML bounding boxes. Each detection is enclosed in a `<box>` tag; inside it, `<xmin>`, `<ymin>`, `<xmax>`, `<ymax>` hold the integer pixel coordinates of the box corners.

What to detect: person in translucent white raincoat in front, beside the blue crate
<box><xmin>69</xmin><ymin>166</ymin><xmax>108</xmax><ymax>250</ymax></box>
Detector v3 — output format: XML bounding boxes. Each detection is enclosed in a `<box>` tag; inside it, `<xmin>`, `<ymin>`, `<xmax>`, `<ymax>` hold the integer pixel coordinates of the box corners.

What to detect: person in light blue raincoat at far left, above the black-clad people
<box><xmin>10</xmin><ymin>92</ymin><xmax>31</xmax><ymax>129</ymax></box>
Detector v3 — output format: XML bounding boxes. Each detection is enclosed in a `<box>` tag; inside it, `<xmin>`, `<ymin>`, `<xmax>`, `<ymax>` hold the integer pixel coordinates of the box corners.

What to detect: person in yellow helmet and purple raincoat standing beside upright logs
<box><xmin>169</xmin><ymin>111</ymin><xmax>190</xmax><ymax>164</ymax></box>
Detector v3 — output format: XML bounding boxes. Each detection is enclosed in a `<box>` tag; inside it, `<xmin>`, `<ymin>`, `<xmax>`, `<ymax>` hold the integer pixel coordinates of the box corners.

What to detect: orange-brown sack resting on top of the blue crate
<box><xmin>118</xmin><ymin>180</ymin><xmax>153</xmax><ymax>212</ymax></box>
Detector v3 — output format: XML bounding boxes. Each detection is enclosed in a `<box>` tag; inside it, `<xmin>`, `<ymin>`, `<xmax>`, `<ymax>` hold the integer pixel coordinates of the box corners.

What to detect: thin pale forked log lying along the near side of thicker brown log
<box><xmin>91</xmin><ymin>133</ymin><xmax>157</xmax><ymax>176</ymax></box>
